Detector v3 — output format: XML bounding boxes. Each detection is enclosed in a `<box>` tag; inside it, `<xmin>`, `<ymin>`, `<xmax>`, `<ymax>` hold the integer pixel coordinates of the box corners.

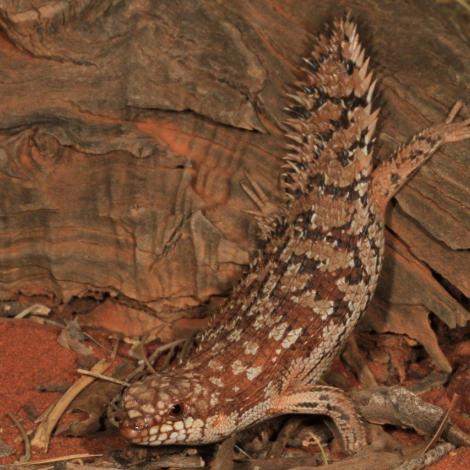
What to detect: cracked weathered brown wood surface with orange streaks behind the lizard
<box><xmin>0</xmin><ymin>0</ymin><xmax>470</xmax><ymax>338</ymax></box>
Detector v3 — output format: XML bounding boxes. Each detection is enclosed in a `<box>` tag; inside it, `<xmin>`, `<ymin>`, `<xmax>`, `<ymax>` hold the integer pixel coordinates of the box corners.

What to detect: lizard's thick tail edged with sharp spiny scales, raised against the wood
<box><xmin>281</xmin><ymin>18</ymin><xmax>379</xmax><ymax>203</ymax></box>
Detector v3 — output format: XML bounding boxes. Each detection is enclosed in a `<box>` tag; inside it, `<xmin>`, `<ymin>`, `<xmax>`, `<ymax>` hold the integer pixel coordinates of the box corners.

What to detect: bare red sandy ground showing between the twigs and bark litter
<box><xmin>0</xmin><ymin>319</ymin><xmax>470</xmax><ymax>470</ymax></box>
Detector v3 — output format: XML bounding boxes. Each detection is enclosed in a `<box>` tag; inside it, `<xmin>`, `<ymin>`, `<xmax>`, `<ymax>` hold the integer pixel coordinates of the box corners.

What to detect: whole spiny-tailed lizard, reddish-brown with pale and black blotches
<box><xmin>121</xmin><ymin>19</ymin><xmax>470</xmax><ymax>453</ymax></box>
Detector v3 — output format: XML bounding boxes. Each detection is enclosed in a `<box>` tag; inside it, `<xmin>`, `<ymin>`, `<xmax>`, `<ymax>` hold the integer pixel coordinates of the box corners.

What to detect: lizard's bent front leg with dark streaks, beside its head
<box><xmin>272</xmin><ymin>385</ymin><xmax>367</xmax><ymax>454</ymax></box>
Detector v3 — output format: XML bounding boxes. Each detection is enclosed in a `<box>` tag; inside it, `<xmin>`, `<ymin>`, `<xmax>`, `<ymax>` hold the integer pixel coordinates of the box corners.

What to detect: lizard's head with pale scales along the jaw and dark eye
<box><xmin>120</xmin><ymin>372</ymin><xmax>231</xmax><ymax>446</ymax></box>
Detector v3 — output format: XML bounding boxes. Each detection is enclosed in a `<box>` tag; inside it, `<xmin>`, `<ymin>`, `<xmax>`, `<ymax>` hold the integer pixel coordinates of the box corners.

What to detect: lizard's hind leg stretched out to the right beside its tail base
<box><xmin>372</xmin><ymin>101</ymin><xmax>470</xmax><ymax>212</ymax></box>
